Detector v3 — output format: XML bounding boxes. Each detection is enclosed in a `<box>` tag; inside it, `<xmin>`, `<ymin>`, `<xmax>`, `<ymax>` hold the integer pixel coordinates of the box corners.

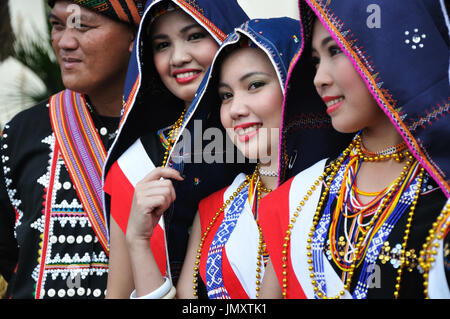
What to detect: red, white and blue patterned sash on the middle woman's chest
<box><xmin>200</xmin><ymin>174</ymin><xmax>264</xmax><ymax>299</ymax></box>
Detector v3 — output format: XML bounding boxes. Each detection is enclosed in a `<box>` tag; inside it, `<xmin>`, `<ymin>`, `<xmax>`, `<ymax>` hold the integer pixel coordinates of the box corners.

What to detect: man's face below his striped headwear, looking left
<box><xmin>49</xmin><ymin>1</ymin><xmax>134</xmax><ymax>94</ymax></box>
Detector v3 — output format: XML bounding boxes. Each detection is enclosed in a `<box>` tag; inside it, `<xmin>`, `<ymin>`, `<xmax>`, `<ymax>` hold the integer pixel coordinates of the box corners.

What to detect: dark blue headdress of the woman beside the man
<box><xmin>104</xmin><ymin>0</ymin><xmax>248</xmax><ymax>176</ymax></box>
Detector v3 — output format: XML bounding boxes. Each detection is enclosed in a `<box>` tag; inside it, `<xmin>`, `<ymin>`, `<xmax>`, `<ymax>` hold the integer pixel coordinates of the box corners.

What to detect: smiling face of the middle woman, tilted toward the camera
<box><xmin>219</xmin><ymin>47</ymin><xmax>283</xmax><ymax>163</ymax></box>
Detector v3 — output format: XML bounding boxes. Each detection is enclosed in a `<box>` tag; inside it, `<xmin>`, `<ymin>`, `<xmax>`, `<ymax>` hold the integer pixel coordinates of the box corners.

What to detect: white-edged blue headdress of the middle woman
<box><xmin>171</xmin><ymin>18</ymin><xmax>308</xmax><ymax>185</ymax></box>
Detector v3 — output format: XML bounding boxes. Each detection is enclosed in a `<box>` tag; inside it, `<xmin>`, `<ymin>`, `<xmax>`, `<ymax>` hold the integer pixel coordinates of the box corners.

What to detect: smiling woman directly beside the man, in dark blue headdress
<box><xmin>104</xmin><ymin>0</ymin><xmax>248</xmax><ymax>298</ymax></box>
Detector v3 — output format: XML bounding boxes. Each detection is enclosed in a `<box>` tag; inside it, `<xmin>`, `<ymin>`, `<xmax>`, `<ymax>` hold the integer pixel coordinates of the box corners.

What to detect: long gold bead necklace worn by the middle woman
<box><xmin>193</xmin><ymin>166</ymin><xmax>272</xmax><ymax>297</ymax></box>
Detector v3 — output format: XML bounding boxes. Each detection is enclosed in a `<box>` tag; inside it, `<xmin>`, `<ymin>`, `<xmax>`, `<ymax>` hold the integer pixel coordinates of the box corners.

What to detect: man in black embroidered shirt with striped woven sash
<box><xmin>0</xmin><ymin>0</ymin><xmax>144</xmax><ymax>299</ymax></box>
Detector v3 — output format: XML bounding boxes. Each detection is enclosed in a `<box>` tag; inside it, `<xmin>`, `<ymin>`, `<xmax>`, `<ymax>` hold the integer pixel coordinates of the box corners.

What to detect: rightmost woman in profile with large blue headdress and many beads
<box><xmin>261</xmin><ymin>0</ymin><xmax>450</xmax><ymax>299</ymax></box>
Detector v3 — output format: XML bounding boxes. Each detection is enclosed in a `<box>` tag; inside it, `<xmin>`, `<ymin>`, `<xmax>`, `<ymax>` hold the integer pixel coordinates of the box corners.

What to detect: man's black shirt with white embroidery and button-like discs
<box><xmin>0</xmin><ymin>101</ymin><xmax>119</xmax><ymax>298</ymax></box>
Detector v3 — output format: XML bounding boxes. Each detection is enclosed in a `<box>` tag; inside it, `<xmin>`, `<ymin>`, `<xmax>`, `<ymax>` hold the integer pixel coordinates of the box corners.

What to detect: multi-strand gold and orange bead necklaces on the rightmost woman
<box><xmin>282</xmin><ymin>136</ymin><xmax>424</xmax><ymax>299</ymax></box>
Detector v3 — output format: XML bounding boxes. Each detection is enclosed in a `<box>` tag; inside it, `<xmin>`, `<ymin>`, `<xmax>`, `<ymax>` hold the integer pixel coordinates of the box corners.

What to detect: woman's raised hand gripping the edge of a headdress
<box><xmin>126</xmin><ymin>167</ymin><xmax>183</xmax><ymax>243</ymax></box>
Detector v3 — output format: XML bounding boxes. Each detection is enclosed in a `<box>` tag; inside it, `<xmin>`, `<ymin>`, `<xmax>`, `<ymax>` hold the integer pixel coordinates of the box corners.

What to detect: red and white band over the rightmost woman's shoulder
<box><xmin>261</xmin><ymin>159</ymin><xmax>351</xmax><ymax>299</ymax></box>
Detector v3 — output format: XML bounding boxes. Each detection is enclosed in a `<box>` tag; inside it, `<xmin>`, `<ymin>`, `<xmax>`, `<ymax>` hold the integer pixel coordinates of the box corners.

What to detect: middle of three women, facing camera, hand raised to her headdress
<box><xmin>122</xmin><ymin>18</ymin><xmax>306</xmax><ymax>298</ymax></box>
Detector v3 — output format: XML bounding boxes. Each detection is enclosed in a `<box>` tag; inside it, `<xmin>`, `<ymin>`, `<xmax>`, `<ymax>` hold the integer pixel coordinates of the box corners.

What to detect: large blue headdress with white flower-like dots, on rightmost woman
<box><xmin>300</xmin><ymin>0</ymin><xmax>450</xmax><ymax>197</ymax></box>
